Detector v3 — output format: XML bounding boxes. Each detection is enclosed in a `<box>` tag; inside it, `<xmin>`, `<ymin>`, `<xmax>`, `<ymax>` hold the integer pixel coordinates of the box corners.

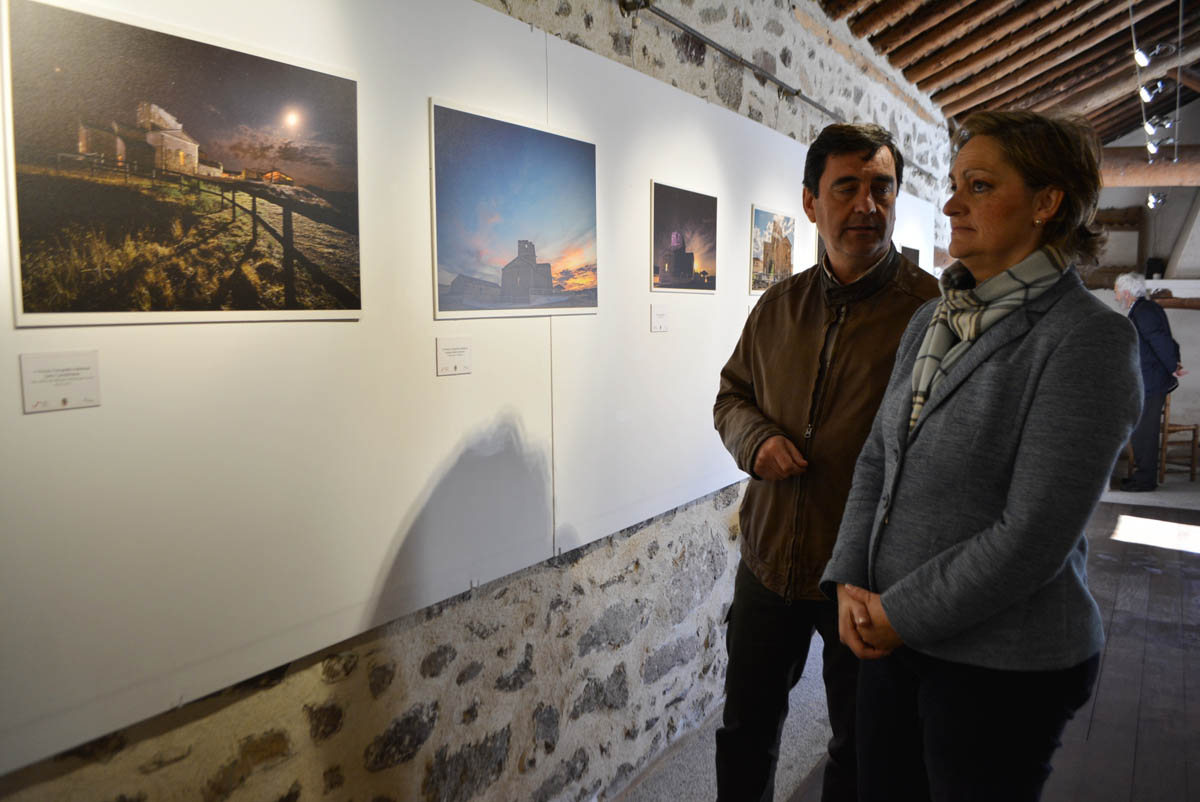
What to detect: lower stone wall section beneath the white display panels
<box><xmin>0</xmin><ymin>485</ymin><xmax>742</xmax><ymax>802</ymax></box>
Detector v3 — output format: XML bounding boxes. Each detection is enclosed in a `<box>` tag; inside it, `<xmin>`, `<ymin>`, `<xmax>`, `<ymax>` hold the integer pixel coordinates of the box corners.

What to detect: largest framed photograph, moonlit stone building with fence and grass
<box><xmin>4</xmin><ymin>0</ymin><xmax>361</xmax><ymax>325</ymax></box>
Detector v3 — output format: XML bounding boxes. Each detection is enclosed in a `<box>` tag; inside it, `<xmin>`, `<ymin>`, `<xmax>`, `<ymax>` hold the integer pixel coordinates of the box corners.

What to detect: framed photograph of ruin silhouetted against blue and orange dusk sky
<box><xmin>430</xmin><ymin>100</ymin><xmax>598</xmax><ymax>318</ymax></box>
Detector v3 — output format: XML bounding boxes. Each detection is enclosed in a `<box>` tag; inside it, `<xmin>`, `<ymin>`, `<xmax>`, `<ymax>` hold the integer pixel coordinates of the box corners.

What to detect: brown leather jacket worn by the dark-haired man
<box><xmin>713</xmin><ymin>249</ymin><xmax>938</xmax><ymax>599</ymax></box>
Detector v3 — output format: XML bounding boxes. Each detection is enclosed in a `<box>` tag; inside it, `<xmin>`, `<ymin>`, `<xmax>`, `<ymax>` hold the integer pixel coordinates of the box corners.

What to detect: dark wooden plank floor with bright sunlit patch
<box><xmin>790</xmin><ymin>504</ymin><xmax>1200</xmax><ymax>802</ymax></box>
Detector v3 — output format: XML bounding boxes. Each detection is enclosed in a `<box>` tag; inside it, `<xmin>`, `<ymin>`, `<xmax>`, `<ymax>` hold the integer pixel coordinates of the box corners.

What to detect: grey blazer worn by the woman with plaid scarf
<box><xmin>821</xmin><ymin>269</ymin><xmax>1142</xmax><ymax>670</ymax></box>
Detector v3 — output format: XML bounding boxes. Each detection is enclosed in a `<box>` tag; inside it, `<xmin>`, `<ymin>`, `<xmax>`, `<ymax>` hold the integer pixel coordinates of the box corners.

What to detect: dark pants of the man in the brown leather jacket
<box><xmin>716</xmin><ymin>563</ymin><xmax>858</xmax><ymax>802</ymax></box>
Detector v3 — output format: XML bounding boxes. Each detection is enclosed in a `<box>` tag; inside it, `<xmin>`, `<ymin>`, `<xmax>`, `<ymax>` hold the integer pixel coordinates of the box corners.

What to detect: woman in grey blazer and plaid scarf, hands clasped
<box><xmin>822</xmin><ymin>112</ymin><xmax>1141</xmax><ymax>802</ymax></box>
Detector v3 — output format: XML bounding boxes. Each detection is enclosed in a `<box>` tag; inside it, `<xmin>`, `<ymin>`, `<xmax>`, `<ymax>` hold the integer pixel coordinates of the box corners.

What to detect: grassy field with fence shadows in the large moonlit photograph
<box><xmin>17</xmin><ymin>166</ymin><xmax>359</xmax><ymax>312</ymax></box>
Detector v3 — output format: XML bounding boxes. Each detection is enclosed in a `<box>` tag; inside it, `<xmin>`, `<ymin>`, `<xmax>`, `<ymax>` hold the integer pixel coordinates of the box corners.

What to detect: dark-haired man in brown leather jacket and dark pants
<box><xmin>713</xmin><ymin>125</ymin><xmax>938</xmax><ymax>802</ymax></box>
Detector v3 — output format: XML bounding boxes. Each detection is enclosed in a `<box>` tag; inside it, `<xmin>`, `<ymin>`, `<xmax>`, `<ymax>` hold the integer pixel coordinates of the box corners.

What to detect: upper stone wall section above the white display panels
<box><xmin>479</xmin><ymin>0</ymin><xmax>949</xmax><ymax>250</ymax></box>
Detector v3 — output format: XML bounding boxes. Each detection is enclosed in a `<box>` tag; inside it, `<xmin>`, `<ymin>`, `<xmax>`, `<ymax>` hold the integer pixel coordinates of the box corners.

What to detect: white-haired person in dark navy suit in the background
<box><xmin>1116</xmin><ymin>273</ymin><xmax>1187</xmax><ymax>492</ymax></box>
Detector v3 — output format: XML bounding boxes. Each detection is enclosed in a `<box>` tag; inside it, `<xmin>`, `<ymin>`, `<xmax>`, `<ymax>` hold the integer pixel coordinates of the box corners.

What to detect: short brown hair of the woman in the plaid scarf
<box><xmin>950</xmin><ymin>112</ymin><xmax>1104</xmax><ymax>264</ymax></box>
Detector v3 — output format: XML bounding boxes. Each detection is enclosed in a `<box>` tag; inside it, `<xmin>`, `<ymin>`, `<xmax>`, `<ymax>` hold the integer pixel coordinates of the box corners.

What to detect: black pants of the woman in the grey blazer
<box><xmin>858</xmin><ymin>647</ymin><xmax>1100</xmax><ymax>802</ymax></box>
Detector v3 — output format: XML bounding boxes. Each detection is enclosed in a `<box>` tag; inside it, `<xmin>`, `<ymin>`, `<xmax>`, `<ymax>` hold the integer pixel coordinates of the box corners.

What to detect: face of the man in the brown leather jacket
<box><xmin>804</xmin><ymin>148</ymin><xmax>898</xmax><ymax>277</ymax></box>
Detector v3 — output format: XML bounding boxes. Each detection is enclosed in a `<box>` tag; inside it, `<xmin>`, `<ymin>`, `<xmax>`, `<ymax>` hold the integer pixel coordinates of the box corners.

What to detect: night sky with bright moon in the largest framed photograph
<box><xmin>11</xmin><ymin>0</ymin><xmax>358</xmax><ymax>191</ymax></box>
